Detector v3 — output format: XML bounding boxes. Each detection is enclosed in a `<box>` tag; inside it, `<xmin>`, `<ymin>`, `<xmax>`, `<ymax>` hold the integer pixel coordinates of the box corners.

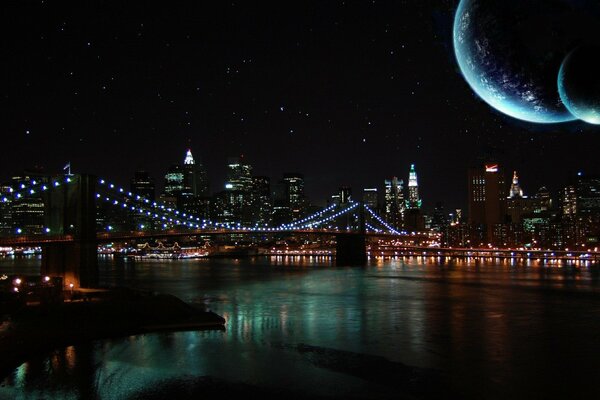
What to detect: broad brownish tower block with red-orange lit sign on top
<box><xmin>468</xmin><ymin>163</ymin><xmax>507</xmax><ymax>245</ymax></box>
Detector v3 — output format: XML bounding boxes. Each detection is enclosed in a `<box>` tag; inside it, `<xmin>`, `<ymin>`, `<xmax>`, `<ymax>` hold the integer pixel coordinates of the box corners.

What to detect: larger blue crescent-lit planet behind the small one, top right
<box><xmin>454</xmin><ymin>0</ymin><xmax>600</xmax><ymax>123</ymax></box>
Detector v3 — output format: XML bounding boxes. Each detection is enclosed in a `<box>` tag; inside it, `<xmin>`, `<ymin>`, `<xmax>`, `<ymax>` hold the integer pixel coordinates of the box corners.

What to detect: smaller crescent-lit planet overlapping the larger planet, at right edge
<box><xmin>558</xmin><ymin>46</ymin><xmax>600</xmax><ymax>125</ymax></box>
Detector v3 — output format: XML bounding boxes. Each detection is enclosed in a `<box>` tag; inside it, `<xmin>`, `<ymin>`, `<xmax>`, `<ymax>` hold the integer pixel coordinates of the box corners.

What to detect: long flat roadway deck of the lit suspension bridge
<box><xmin>0</xmin><ymin>229</ymin><xmax>420</xmax><ymax>247</ymax></box>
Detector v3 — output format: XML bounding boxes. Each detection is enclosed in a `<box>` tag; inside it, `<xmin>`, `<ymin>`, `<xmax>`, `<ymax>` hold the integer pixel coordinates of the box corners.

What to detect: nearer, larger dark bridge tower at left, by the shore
<box><xmin>42</xmin><ymin>174</ymin><xmax>98</xmax><ymax>288</ymax></box>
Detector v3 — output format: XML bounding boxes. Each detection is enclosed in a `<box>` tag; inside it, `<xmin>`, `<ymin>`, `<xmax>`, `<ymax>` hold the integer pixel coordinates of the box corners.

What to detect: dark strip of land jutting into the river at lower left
<box><xmin>0</xmin><ymin>289</ymin><xmax>225</xmax><ymax>377</ymax></box>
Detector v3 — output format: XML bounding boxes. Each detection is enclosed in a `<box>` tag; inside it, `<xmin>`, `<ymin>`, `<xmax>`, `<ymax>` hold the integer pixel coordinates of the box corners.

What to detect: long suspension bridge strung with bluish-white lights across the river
<box><xmin>0</xmin><ymin>174</ymin><xmax>420</xmax><ymax>287</ymax></box>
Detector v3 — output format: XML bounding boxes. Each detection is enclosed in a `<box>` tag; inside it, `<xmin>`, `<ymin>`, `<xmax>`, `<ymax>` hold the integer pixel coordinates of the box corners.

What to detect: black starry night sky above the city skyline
<box><xmin>0</xmin><ymin>0</ymin><xmax>600</xmax><ymax>209</ymax></box>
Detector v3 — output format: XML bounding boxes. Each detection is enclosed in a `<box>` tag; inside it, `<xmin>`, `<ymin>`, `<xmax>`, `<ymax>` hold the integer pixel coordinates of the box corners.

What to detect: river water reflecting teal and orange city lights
<box><xmin>0</xmin><ymin>257</ymin><xmax>600</xmax><ymax>399</ymax></box>
